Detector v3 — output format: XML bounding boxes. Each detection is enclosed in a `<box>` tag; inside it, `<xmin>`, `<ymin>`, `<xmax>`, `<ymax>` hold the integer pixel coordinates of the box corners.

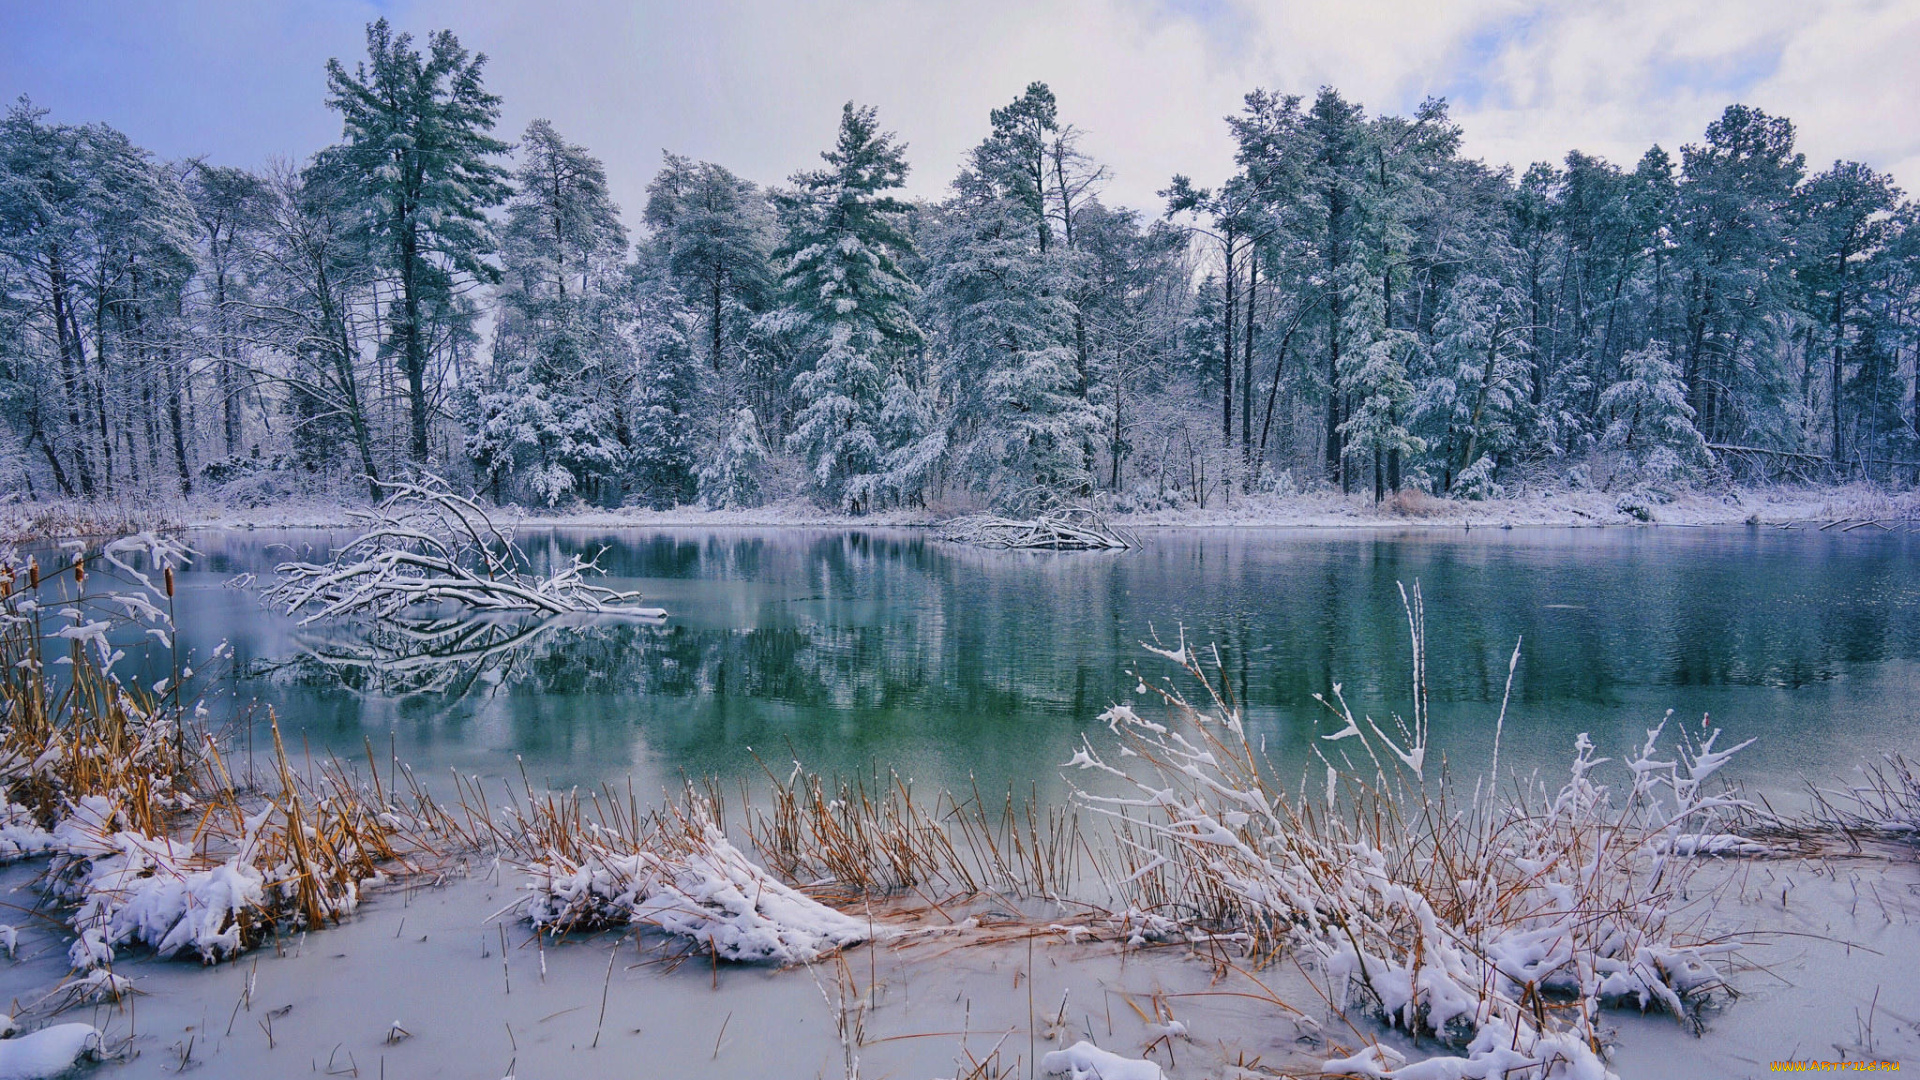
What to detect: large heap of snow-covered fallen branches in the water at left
<box><xmin>265</xmin><ymin>477</ymin><xmax>666</xmax><ymax>626</ymax></box>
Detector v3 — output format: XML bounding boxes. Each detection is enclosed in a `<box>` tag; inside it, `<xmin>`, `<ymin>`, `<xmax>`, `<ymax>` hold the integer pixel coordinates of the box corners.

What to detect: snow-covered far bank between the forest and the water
<box><xmin>0</xmin><ymin>484</ymin><xmax>1920</xmax><ymax>542</ymax></box>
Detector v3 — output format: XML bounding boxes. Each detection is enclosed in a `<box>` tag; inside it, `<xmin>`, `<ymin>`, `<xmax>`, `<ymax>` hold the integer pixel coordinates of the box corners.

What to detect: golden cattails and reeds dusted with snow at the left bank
<box><xmin>0</xmin><ymin>536</ymin><xmax>439</xmax><ymax>999</ymax></box>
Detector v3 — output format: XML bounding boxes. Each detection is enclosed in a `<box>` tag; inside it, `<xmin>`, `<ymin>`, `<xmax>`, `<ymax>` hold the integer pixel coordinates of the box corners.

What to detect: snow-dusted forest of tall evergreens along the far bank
<box><xmin>0</xmin><ymin>21</ymin><xmax>1920</xmax><ymax>513</ymax></box>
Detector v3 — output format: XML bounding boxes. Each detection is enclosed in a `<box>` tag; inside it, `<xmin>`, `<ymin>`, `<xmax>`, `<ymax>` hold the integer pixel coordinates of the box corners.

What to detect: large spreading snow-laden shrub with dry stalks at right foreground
<box><xmin>1069</xmin><ymin>588</ymin><xmax>1749</xmax><ymax>1080</ymax></box>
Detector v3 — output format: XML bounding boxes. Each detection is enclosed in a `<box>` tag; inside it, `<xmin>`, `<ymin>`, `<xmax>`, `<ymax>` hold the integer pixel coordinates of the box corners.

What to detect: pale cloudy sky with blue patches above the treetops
<box><xmin>0</xmin><ymin>0</ymin><xmax>1920</xmax><ymax>217</ymax></box>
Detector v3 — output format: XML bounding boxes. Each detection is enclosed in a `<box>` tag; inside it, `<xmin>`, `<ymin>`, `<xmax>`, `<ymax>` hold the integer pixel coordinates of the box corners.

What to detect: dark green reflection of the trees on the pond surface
<box><xmin>257</xmin><ymin>530</ymin><xmax>1916</xmax><ymax>723</ymax></box>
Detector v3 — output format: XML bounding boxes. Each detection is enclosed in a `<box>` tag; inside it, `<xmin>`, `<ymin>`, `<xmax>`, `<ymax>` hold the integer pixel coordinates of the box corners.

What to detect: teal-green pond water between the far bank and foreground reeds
<box><xmin>157</xmin><ymin>527</ymin><xmax>1920</xmax><ymax>799</ymax></box>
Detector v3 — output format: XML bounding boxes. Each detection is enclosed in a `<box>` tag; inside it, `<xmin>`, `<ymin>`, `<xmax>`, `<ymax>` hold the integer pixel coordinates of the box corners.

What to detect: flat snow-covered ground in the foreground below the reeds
<box><xmin>0</xmin><ymin>841</ymin><xmax>1920</xmax><ymax>1080</ymax></box>
